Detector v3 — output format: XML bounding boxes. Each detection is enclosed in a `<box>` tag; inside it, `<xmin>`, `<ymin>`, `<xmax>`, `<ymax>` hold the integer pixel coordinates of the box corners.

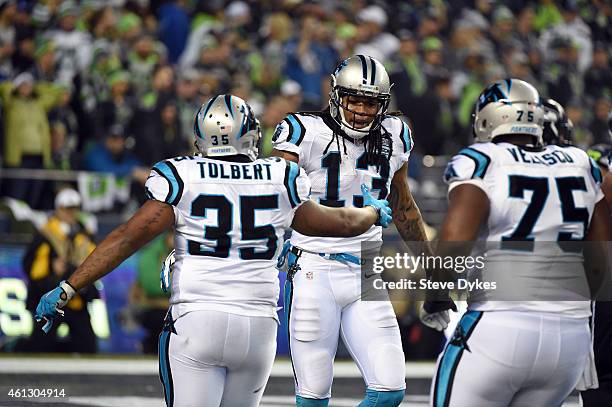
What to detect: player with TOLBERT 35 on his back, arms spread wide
<box><xmin>36</xmin><ymin>95</ymin><xmax>391</xmax><ymax>407</ymax></box>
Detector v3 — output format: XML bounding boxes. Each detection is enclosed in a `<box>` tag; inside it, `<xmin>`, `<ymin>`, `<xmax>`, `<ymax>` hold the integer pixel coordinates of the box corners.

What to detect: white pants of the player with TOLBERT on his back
<box><xmin>159</xmin><ymin>311</ymin><xmax>278</xmax><ymax>407</ymax></box>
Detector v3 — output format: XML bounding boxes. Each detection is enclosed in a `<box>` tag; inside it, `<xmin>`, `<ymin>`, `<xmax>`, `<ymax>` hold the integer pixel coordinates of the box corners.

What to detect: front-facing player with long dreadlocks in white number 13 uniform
<box><xmin>273</xmin><ymin>55</ymin><xmax>426</xmax><ymax>407</ymax></box>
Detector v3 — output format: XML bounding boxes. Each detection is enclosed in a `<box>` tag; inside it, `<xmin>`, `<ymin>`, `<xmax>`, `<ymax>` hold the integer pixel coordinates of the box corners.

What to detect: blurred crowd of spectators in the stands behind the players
<box><xmin>0</xmin><ymin>0</ymin><xmax>612</xmax><ymax>209</ymax></box>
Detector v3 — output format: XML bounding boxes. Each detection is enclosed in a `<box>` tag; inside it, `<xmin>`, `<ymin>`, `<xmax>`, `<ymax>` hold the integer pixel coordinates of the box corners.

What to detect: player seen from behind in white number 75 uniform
<box><xmin>423</xmin><ymin>79</ymin><xmax>611</xmax><ymax>407</ymax></box>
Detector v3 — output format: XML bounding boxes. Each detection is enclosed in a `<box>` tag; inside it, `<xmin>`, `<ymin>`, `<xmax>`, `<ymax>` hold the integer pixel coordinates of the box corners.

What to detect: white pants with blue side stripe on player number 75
<box><xmin>430</xmin><ymin>311</ymin><xmax>591</xmax><ymax>407</ymax></box>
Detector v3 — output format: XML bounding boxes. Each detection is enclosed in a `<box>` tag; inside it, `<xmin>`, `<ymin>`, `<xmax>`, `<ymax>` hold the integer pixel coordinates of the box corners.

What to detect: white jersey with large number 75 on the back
<box><xmin>444</xmin><ymin>143</ymin><xmax>603</xmax><ymax>318</ymax></box>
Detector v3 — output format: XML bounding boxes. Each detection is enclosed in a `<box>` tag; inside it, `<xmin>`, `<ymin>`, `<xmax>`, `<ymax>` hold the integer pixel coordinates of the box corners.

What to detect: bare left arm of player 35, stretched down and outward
<box><xmin>68</xmin><ymin>200</ymin><xmax>174</xmax><ymax>291</ymax></box>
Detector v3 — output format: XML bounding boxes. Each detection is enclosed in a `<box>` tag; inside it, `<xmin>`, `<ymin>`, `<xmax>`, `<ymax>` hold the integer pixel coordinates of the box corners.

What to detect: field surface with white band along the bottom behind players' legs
<box><xmin>0</xmin><ymin>356</ymin><xmax>578</xmax><ymax>407</ymax></box>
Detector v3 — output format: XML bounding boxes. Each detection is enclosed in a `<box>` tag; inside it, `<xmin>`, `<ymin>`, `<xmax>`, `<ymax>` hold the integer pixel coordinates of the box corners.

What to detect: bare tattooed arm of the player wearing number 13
<box><xmin>389</xmin><ymin>163</ymin><xmax>431</xmax><ymax>255</ymax></box>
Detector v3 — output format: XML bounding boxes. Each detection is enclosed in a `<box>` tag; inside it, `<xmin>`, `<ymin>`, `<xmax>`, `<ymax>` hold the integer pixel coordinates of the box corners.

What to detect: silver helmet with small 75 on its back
<box><xmin>472</xmin><ymin>78</ymin><xmax>544</xmax><ymax>144</ymax></box>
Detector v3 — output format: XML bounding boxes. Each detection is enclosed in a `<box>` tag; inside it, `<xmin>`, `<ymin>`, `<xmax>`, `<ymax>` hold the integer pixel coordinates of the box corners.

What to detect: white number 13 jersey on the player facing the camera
<box><xmin>272</xmin><ymin>112</ymin><xmax>412</xmax><ymax>254</ymax></box>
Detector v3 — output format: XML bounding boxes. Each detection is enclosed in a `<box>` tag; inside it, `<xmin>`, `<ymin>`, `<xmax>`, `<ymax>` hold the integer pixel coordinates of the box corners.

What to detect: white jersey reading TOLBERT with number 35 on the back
<box><xmin>145</xmin><ymin>156</ymin><xmax>310</xmax><ymax>318</ymax></box>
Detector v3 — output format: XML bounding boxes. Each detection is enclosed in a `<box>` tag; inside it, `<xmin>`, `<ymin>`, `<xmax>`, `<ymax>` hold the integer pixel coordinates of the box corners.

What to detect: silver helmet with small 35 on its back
<box><xmin>193</xmin><ymin>95</ymin><xmax>261</xmax><ymax>160</ymax></box>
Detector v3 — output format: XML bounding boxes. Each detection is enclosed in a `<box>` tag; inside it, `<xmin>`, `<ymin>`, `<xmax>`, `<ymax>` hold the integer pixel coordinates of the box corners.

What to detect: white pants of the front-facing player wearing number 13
<box><xmin>285</xmin><ymin>253</ymin><xmax>406</xmax><ymax>399</ymax></box>
